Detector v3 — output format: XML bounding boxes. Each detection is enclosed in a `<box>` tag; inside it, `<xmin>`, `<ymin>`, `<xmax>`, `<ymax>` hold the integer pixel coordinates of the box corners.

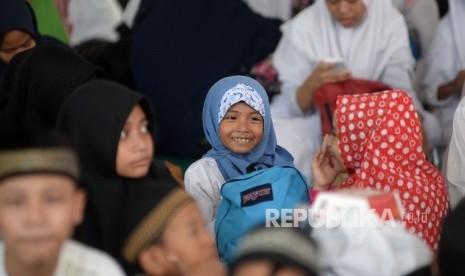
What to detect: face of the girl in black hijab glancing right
<box><xmin>116</xmin><ymin>105</ymin><xmax>153</xmax><ymax>178</ymax></box>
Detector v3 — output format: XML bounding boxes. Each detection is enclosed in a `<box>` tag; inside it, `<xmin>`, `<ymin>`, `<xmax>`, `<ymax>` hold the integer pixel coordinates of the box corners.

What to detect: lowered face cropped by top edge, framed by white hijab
<box><xmin>326</xmin><ymin>0</ymin><xmax>366</xmax><ymax>28</ymax></box>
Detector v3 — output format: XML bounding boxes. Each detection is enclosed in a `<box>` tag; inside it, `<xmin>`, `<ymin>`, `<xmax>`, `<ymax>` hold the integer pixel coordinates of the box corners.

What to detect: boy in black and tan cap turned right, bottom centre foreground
<box><xmin>121</xmin><ymin>185</ymin><xmax>225</xmax><ymax>276</ymax></box>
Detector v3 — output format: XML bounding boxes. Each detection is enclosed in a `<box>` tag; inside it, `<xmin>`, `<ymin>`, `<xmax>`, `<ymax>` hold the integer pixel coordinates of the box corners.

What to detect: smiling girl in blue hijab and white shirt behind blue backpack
<box><xmin>184</xmin><ymin>76</ymin><xmax>293</xmax><ymax>232</ymax></box>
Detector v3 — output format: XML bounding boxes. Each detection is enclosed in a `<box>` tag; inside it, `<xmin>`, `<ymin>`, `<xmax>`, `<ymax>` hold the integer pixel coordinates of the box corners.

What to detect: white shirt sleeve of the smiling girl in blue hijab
<box><xmin>184</xmin><ymin>157</ymin><xmax>225</xmax><ymax>233</ymax></box>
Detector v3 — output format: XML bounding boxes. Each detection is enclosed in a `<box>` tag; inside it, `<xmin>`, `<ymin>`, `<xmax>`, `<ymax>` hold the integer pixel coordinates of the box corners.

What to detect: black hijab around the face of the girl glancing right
<box><xmin>57</xmin><ymin>80</ymin><xmax>178</xmax><ymax>258</ymax></box>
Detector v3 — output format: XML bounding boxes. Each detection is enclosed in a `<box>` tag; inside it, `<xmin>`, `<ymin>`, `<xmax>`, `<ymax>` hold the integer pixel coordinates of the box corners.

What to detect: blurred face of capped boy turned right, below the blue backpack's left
<box><xmin>161</xmin><ymin>202</ymin><xmax>218</xmax><ymax>274</ymax></box>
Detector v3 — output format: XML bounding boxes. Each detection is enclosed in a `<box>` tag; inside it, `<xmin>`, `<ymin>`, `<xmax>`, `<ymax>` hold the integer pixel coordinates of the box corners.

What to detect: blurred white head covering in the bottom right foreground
<box><xmin>312</xmin><ymin>222</ymin><xmax>432</xmax><ymax>276</ymax></box>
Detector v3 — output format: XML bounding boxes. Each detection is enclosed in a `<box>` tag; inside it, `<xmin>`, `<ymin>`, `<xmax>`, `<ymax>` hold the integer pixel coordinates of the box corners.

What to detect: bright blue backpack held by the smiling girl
<box><xmin>215</xmin><ymin>166</ymin><xmax>309</xmax><ymax>265</ymax></box>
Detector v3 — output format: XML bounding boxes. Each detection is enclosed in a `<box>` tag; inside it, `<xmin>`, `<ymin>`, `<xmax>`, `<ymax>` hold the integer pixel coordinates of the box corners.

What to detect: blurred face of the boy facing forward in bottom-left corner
<box><xmin>0</xmin><ymin>174</ymin><xmax>85</xmax><ymax>267</ymax></box>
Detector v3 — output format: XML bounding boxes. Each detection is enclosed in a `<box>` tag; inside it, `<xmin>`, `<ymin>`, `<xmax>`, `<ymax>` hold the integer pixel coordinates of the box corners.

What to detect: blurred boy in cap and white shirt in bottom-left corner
<box><xmin>0</xmin><ymin>130</ymin><xmax>124</xmax><ymax>276</ymax></box>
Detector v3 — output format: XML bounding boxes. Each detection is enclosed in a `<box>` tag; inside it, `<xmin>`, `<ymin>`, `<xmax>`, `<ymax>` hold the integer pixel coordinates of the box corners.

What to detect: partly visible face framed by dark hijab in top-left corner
<box><xmin>0</xmin><ymin>30</ymin><xmax>36</xmax><ymax>64</ymax></box>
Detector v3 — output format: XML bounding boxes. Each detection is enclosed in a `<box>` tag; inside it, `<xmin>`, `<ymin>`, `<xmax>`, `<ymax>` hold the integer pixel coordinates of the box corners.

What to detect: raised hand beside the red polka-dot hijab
<box><xmin>312</xmin><ymin>134</ymin><xmax>339</xmax><ymax>191</ymax></box>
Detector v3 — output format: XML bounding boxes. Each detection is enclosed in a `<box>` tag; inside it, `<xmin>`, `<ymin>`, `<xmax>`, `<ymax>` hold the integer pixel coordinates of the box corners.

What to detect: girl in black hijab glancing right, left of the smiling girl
<box><xmin>57</xmin><ymin>80</ymin><xmax>178</xmax><ymax>258</ymax></box>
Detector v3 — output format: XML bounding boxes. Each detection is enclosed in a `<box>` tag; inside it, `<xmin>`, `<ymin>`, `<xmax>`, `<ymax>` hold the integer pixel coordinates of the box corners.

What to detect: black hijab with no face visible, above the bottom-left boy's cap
<box><xmin>0</xmin><ymin>45</ymin><xmax>100</xmax><ymax>130</ymax></box>
